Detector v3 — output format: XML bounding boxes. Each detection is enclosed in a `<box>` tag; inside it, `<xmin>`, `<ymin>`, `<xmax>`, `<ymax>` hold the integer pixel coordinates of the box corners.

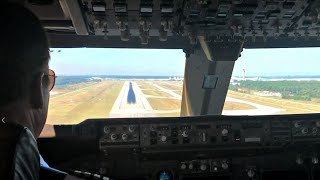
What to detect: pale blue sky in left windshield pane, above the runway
<box><xmin>50</xmin><ymin>48</ymin><xmax>185</xmax><ymax>76</ymax></box>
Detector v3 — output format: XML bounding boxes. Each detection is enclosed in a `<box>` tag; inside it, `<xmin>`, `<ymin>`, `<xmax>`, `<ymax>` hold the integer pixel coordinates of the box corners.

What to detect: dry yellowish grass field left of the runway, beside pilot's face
<box><xmin>47</xmin><ymin>80</ymin><xmax>124</xmax><ymax>124</ymax></box>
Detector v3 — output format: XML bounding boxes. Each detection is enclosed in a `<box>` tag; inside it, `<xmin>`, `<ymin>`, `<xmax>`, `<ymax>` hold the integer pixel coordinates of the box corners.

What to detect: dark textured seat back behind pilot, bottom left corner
<box><xmin>0</xmin><ymin>121</ymin><xmax>40</xmax><ymax>180</ymax></box>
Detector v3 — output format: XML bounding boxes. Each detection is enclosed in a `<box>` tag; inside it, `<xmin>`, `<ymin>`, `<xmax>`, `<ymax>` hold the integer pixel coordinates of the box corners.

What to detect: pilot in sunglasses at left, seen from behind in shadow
<box><xmin>0</xmin><ymin>3</ymin><xmax>86</xmax><ymax>180</ymax></box>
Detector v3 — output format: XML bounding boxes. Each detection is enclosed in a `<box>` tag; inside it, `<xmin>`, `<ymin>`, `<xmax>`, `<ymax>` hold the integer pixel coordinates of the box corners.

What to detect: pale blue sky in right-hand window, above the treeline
<box><xmin>233</xmin><ymin>48</ymin><xmax>320</xmax><ymax>76</ymax></box>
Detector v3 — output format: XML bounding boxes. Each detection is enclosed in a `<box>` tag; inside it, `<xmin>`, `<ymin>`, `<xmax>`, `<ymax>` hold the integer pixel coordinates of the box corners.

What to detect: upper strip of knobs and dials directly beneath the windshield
<box><xmin>95</xmin><ymin>116</ymin><xmax>320</xmax><ymax>152</ymax></box>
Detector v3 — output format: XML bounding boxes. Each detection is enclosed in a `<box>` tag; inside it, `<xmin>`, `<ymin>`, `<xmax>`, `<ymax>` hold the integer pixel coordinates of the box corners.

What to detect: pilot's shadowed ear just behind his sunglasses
<box><xmin>29</xmin><ymin>74</ymin><xmax>44</xmax><ymax>109</ymax></box>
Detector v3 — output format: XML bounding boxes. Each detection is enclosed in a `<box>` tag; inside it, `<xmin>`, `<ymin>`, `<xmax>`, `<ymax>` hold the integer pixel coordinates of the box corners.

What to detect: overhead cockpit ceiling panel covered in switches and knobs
<box><xmin>26</xmin><ymin>0</ymin><xmax>320</xmax><ymax>48</ymax></box>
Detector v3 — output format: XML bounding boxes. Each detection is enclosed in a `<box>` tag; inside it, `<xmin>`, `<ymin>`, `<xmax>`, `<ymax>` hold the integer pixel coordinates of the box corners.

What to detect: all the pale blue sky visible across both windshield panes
<box><xmin>50</xmin><ymin>48</ymin><xmax>320</xmax><ymax>76</ymax></box>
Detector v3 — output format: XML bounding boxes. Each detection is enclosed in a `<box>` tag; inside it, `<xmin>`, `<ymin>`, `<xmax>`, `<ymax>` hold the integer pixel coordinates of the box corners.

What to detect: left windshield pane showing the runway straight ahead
<box><xmin>47</xmin><ymin>48</ymin><xmax>185</xmax><ymax>125</ymax></box>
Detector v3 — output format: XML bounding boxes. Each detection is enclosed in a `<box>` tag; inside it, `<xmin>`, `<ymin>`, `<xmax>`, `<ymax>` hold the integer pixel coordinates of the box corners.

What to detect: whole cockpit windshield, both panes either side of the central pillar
<box><xmin>47</xmin><ymin>48</ymin><xmax>320</xmax><ymax>124</ymax></box>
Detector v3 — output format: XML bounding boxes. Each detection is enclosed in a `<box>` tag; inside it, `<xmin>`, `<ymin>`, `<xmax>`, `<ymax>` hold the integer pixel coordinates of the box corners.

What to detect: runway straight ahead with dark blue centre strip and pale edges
<box><xmin>109</xmin><ymin>81</ymin><xmax>155</xmax><ymax>118</ymax></box>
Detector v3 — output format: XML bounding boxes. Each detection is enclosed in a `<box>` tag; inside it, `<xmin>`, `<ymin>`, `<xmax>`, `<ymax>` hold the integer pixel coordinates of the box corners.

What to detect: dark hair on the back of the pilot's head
<box><xmin>0</xmin><ymin>3</ymin><xmax>50</xmax><ymax>107</ymax></box>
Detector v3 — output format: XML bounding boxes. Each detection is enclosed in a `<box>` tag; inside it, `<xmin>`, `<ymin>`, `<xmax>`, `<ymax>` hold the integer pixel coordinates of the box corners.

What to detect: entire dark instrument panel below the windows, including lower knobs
<box><xmin>48</xmin><ymin>114</ymin><xmax>320</xmax><ymax>179</ymax></box>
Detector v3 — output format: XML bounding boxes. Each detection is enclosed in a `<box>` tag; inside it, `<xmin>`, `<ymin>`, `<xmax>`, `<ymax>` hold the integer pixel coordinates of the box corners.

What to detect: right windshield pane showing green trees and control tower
<box><xmin>223</xmin><ymin>48</ymin><xmax>320</xmax><ymax>115</ymax></box>
